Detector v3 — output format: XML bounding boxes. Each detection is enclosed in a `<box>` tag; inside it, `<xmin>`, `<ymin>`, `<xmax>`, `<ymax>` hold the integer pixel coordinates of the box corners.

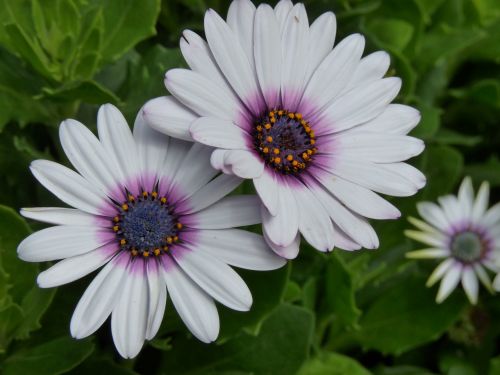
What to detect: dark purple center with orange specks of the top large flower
<box><xmin>252</xmin><ymin>109</ymin><xmax>317</xmax><ymax>174</ymax></box>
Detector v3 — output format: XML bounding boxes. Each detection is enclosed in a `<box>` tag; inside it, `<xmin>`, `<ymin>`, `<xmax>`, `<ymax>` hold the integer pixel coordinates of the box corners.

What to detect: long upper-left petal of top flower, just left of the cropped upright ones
<box><xmin>205</xmin><ymin>8</ymin><xmax>260</xmax><ymax>114</ymax></box>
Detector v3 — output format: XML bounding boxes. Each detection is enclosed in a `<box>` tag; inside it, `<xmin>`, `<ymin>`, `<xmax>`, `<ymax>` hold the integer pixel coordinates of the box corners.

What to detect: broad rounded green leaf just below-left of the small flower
<box><xmin>356</xmin><ymin>275</ymin><xmax>465</xmax><ymax>355</ymax></box>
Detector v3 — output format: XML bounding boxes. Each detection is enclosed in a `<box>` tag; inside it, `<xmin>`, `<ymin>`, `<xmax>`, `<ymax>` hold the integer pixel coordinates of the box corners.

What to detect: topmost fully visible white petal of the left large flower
<box><xmin>97</xmin><ymin>104</ymin><xmax>140</xmax><ymax>192</ymax></box>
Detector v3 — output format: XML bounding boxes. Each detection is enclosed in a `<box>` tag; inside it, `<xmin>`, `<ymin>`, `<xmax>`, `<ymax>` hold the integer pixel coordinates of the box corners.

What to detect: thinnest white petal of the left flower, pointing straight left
<box><xmin>21</xmin><ymin>207</ymin><xmax>100</xmax><ymax>225</ymax></box>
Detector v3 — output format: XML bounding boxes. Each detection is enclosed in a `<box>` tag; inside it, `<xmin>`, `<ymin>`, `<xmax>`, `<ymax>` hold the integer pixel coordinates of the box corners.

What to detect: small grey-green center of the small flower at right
<box><xmin>450</xmin><ymin>230</ymin><xmax>488</xmax><ymax>263</ymax></box>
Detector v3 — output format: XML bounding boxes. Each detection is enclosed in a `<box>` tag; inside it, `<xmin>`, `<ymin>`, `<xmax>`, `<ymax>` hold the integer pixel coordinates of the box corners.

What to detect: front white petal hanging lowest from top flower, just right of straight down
<box><xmin>293</xmin><ymin>186</ymin><xmax>335</xmax><ymax>252</ymax></box>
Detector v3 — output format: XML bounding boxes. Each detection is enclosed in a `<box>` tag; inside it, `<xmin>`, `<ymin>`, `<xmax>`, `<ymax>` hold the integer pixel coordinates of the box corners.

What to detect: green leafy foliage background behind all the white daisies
<box><xmin>0</xmin><ymin>0</ymin><xmax>500</xmax><ymax>375</ymax></box>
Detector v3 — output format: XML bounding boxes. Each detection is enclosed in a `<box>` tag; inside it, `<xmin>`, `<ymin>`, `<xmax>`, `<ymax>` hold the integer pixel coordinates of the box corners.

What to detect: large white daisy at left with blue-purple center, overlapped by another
<box><xmin>18</xmin><ymin>104</ymin><xmax>284</xmax><ymax>358</ymax></box>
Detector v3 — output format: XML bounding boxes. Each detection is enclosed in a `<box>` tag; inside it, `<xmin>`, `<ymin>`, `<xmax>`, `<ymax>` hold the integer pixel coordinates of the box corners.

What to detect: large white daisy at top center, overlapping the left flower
<box><xmin>144</xmin><ymin>0</ymin><xmax>425</xmax><ymax>258</ymax></box>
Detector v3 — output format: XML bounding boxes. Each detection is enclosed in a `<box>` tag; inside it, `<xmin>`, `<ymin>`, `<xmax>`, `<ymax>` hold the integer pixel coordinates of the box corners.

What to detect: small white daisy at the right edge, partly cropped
<box><xmin>405</xmin><ymin>177</ymin><xmax>500</xmax><ymax>304</ymax></box>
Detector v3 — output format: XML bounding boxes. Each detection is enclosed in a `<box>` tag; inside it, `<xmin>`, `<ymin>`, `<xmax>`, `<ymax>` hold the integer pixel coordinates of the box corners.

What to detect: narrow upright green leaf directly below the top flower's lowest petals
<box><xmin>324</xmin><ymin>253</ymin><xmax>361</xmax><ymax>326</ymax></box>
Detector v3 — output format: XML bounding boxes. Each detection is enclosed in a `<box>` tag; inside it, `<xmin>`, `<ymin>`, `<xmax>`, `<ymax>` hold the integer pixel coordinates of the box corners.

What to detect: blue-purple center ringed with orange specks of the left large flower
<box><xmin>112</xmin><ymin>191</ymin><xmax>182</xmax><ymax>257</ymax></box>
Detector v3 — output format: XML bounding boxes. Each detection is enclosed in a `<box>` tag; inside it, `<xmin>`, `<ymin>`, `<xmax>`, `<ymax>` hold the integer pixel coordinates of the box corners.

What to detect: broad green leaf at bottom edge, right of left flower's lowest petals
<box><xmin>161</xmin><ymin>304</ymin><xmax>314</xmax><ymax>375</ymax></box>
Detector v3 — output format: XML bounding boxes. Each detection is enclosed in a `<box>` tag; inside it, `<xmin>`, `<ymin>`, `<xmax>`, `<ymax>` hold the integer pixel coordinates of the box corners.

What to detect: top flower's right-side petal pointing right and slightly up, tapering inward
<box><xmin>350</xmin><ymin>104</ymin><xmax>421</xmax><ymax>135</ymax></box>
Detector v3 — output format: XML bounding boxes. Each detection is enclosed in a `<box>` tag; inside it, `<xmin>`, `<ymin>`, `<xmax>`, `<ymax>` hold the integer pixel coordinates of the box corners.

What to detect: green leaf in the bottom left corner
<box><xmin>3</xmin><ymin>337</ymin><xmax>94</xmax><ymax>375</ymax></box>
